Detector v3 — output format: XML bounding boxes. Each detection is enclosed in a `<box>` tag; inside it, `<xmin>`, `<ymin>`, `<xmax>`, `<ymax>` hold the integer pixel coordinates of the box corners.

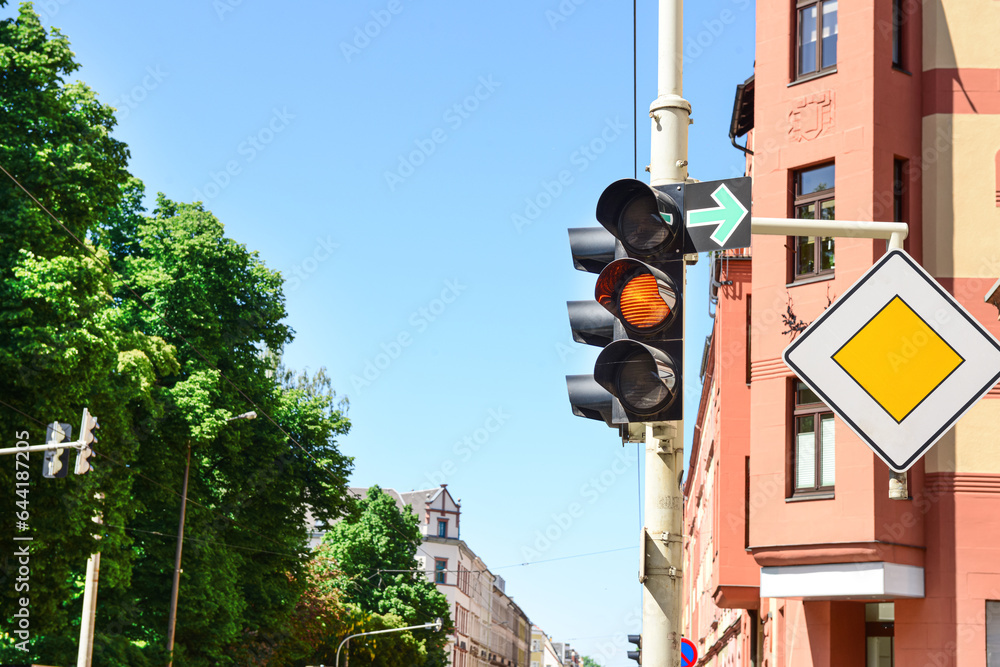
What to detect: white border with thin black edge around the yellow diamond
<box><xmin>782</xmin><ymin>250</ymin><xmax>1000</xmax><ymax>472</ymax></box>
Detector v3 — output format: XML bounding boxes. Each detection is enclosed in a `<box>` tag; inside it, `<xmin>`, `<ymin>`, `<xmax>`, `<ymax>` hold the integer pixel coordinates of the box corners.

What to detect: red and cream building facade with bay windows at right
<box><xmin>685</xmin><ymin>0</ymin><xmax>1000</xmax><ymax>667</ymax></box>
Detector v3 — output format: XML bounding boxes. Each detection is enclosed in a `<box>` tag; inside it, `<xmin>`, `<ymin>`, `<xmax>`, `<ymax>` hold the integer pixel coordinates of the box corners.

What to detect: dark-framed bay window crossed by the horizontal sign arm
<box><xmin>793</xmin><ymin>164</ymin><xmax>836</xmax><ymax>280</ymax></box>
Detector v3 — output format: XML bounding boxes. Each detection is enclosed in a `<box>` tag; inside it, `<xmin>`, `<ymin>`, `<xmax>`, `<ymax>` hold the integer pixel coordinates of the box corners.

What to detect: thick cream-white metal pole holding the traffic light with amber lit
<box><xmin>639</xmin><ymin>0</ymin><xmax>691</xmax><ymax>667</ymax></box>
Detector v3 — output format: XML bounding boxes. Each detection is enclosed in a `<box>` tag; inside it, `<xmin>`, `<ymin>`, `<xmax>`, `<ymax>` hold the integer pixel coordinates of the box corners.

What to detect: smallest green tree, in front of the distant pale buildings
<box><xmin>318</xmin><ymin>486</ymin><xmax>453</xmax><ymax>665</ymax></box>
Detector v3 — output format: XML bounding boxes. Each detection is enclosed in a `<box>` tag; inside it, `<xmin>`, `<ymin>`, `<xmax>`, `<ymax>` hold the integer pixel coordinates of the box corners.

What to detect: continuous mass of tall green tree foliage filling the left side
<box><xmin>0</xmin><ymin>0</ymin><xmax>358</xmax><ymax>667</ymax></box>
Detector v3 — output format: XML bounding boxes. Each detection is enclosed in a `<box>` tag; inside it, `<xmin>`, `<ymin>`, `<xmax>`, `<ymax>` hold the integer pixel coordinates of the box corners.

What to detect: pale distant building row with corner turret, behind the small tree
<box><xmin>310</xmin><ymin>484</ymin><xmax>531</xmax><ymax>667</ymax></box>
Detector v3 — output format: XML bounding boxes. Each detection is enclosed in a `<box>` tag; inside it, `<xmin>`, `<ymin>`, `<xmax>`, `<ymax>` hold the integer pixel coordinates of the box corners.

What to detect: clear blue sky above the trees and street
<box><xmin>9</xmin><ymin>0</ymin><xmax>754</xmax><ymax>666</ymax></box>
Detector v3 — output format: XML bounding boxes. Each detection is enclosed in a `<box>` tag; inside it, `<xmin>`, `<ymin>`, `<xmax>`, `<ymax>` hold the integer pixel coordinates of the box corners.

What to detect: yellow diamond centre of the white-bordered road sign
<box><xmin>833</xmin><ymin>296</ymin><xmax>965</xmax><ymax>423</ymax></box>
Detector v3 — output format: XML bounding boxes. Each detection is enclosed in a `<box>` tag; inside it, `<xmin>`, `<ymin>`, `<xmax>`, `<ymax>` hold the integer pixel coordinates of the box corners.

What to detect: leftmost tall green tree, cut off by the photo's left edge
<box><xmin>0</xmin><ymin>0</ymin><xmax>177</xmax><ymax>662</ymax></box>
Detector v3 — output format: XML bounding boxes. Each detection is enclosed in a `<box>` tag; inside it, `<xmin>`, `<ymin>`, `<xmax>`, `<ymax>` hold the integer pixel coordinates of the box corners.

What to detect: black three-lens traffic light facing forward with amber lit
<box><xmin>594</xmin><ymin>179</ymin><xmax>684</xmax><ymax>424</ymax></box>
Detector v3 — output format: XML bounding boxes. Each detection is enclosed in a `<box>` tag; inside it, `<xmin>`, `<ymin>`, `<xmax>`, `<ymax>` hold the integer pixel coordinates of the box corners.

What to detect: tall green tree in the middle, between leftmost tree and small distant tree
<box><xmin>106</xmin><ymin>195</ymin><xmax>351</xmax><ymax>666</ymax></box>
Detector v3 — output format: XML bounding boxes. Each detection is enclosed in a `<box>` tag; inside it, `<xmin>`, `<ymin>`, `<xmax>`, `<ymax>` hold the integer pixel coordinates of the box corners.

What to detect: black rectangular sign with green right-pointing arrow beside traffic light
<box><xmin>684</xmin><ymin>178</ymin><xmax>751</xmax><ymax>253</ymax></box>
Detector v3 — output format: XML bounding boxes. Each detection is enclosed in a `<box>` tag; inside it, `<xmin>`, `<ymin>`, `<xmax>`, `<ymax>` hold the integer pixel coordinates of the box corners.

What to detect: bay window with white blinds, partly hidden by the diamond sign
<box><xmin>792</xmin><ymin>382</ymin><xmax>836</xmax><ymax>495</ymax></box>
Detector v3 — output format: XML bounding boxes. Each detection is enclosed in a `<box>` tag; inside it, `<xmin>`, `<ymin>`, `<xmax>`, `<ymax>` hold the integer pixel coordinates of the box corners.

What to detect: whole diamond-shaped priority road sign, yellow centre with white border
<box><xmin>783</xmin><ymin>250</ymin><xmax>1000</xmax><ymax>472</ymax></box>
